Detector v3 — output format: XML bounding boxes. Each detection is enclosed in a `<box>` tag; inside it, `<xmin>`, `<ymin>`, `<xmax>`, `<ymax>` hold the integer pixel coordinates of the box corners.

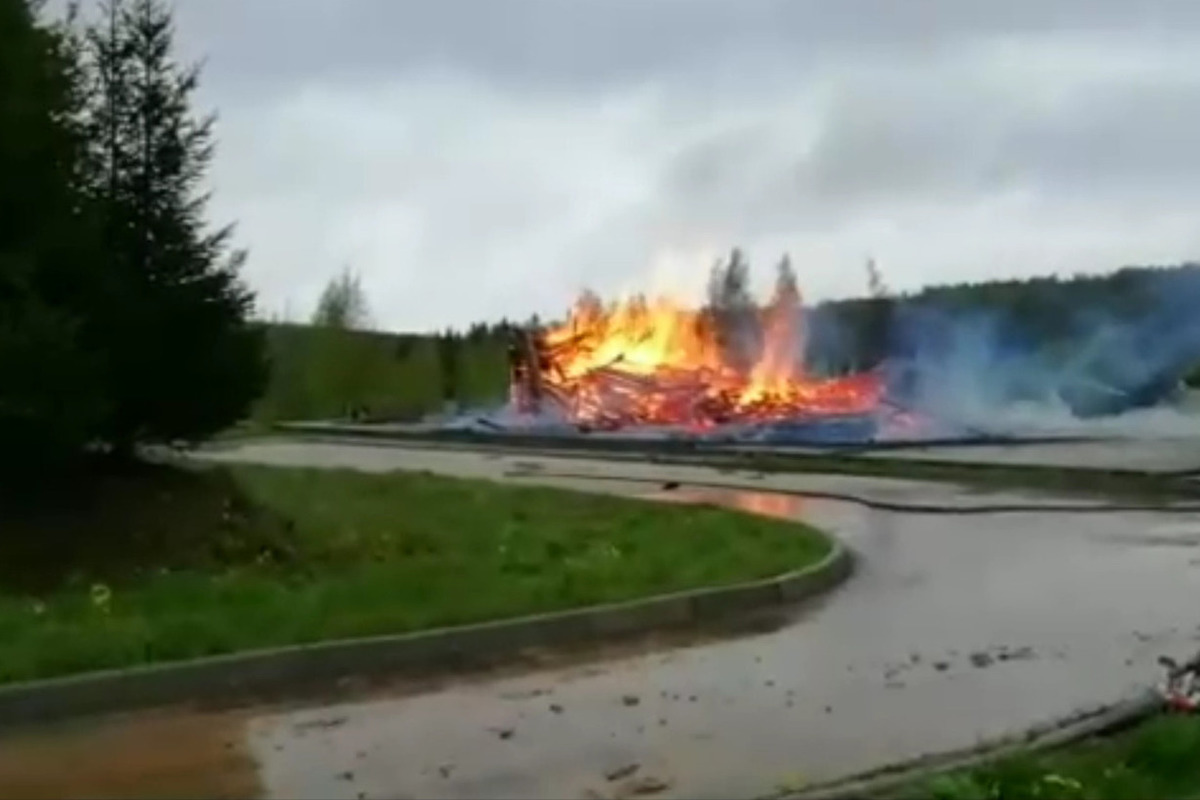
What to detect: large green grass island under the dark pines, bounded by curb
<box><xmin>0</xmin><ymin>465</ymin><xmax>829</xmax><ymax>682</ymax></box>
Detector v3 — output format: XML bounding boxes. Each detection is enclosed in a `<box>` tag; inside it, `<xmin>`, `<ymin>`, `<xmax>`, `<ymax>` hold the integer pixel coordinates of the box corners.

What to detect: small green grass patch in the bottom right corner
<box><xmin>904</xmin><ymin>715</ymin><xmax>1200</xmax><ymax>800</ymax></box>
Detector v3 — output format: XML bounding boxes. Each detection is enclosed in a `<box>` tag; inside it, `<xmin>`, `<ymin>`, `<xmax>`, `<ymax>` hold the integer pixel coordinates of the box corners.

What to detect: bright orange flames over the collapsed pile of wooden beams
<box><xmin>511</xmin><ymin>256</ymin><xmax>882</xmax><ymax>428</ymax></box>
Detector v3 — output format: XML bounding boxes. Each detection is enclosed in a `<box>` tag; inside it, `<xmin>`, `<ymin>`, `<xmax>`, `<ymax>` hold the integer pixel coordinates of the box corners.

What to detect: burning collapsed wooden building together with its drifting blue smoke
<box><xmin>494</xmin><ymin>252</ymin><xmax>1200</xmax><ymax>444</ymax></box>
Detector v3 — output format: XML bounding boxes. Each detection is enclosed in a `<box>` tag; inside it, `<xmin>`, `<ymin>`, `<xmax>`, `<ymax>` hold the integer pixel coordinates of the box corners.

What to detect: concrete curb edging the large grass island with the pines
<box><xmin>0</xmin><ymin>534</ymin><xmax>854</xmax><ymax>728</ymax></box>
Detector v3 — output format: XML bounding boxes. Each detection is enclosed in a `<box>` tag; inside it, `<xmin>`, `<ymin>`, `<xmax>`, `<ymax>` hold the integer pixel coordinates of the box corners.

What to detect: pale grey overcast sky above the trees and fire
<box><xmin>154</xmin><ymin>0</ymin><xmax>1200</xmax><ymax>330</ymax></box>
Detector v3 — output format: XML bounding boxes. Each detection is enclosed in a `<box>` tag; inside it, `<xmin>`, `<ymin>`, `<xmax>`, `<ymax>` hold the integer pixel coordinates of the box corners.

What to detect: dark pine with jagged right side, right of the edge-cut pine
<box><xmin>86</xmin><ymin>0</ymin><xmax>266</xmax><ymax>452</ymax></box>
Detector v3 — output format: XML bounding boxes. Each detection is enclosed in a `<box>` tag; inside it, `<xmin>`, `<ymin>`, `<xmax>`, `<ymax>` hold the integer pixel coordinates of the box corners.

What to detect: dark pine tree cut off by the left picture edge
<box><xmin>0</xmin><ymin>0</ymin><xmax>106</xmax><ymax>488</ymax></box>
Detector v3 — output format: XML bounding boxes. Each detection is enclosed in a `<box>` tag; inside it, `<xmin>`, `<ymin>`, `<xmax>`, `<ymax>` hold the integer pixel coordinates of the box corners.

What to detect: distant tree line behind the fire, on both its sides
<box><xmin>290</xmin><ymin>249</ymin><xmax>1200</xmax><ymax>417</ymax></box>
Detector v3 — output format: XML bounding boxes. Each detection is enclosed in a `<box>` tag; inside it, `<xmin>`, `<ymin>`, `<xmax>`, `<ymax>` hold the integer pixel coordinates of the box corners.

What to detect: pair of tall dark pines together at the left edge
<box><xmin>0</xmin><ymin>0</ymin><xmax>268</xmax><ymax>485</ymax></box>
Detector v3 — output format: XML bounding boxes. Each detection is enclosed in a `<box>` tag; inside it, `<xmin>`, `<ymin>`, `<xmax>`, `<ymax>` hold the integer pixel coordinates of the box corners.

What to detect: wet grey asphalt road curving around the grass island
<box><xmin>0</xmin><ymin>443</ymin><xmax>1200</xmax><ymax>798</ymax></box>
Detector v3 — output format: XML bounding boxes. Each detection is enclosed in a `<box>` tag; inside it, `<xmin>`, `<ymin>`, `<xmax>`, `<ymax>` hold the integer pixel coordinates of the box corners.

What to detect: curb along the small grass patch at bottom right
<box><xmin>761</xmin><ymin>688</ymin><xmax>1163</xmax><ymax>800</ymax></box>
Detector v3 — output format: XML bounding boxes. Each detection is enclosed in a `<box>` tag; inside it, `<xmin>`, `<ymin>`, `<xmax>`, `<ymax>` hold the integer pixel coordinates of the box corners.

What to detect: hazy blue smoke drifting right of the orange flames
<box><xmin>888</xmin><ymin>266</ymin><xmax>1200</xmax><ymax>420</ymax></box>
